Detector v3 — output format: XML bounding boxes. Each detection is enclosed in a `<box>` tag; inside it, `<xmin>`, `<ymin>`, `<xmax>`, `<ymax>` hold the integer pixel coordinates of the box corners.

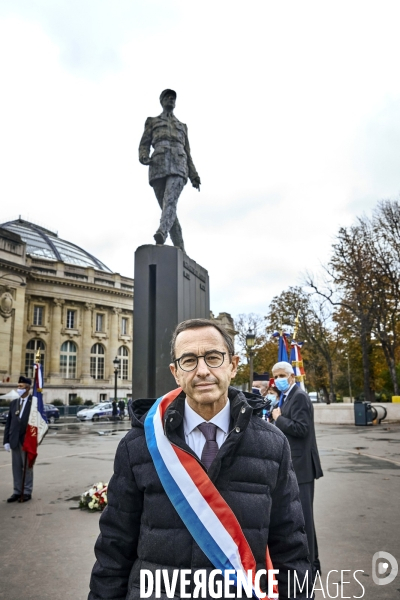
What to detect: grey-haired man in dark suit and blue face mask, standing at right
<box><xmin>272</xmin><ymin>362</ymin><xmax>323</xmax><ymax>575</ymax></box>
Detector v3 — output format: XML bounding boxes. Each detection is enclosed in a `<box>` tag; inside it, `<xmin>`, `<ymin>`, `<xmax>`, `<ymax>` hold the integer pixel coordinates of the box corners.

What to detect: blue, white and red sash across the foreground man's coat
<box><xmin>144</xmin><ymin>388</ymin><xmax>273</xmax><ymax>595</ymax></box>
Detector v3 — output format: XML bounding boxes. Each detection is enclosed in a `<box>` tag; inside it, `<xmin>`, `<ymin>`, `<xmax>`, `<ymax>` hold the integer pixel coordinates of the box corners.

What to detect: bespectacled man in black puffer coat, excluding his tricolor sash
<box><xmin>89</xmin><ymin>319</ymin><xmax>311</xmax><ymax>600</ymax></box>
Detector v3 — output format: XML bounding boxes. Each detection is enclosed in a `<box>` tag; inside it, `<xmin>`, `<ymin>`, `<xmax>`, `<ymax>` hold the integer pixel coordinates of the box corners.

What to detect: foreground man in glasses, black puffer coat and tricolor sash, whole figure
<box><xmin>89</xmin><ymin>319</ymin><xmax>311</xmax><ymax>600</ymax></box>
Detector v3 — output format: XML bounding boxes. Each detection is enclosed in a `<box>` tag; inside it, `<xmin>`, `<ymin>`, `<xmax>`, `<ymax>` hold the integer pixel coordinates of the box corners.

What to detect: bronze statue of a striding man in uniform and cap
<box><xmin>139</xmin><ymin>90</ymin><xmax>200</xmax><ymax>251</ymax></box>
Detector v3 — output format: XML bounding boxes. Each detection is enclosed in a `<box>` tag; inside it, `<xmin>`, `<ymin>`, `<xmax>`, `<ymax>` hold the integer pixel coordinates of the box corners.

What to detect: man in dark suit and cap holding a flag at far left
<box><xmin>3</xmin><ymin>375</ymin><xmax>33</xmax><ymax>502</ymax></box>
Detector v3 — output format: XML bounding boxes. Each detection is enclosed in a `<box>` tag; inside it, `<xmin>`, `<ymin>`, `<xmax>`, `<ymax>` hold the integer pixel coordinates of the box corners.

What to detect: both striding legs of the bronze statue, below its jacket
<box><xmin>153</xmin><ymin>175</ymin><xmax>186</xmax><ymax>250</ymax></box>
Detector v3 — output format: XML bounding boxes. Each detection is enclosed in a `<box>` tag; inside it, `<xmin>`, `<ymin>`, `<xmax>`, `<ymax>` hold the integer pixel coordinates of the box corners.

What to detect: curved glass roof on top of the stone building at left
<box><xmin>0</xmin><ymin>219</ymin><xmax>112</xmax><ymax>273</ymax></box>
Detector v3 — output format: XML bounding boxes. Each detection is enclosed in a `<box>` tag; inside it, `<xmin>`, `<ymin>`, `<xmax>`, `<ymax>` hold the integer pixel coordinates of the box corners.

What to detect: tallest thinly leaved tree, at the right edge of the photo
<box><xmin>307</xmin><ymin>201</ymin><xmax>400</xmax><ymax>400</ymax></box>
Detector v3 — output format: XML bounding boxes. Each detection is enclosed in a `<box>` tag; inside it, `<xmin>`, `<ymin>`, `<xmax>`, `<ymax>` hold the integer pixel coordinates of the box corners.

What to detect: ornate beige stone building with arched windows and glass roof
<box><xmin>0</xmin><ymin>219</ymin><xmax>235</xmax><ymax>404</ymax></box>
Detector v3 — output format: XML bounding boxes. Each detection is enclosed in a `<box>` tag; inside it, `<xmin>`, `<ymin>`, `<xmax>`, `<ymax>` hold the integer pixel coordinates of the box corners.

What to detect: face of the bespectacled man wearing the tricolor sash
<box><xmin>170</xmin><ymin>327</ymin><xmax>239</xmax><ymax>412</ymax></box>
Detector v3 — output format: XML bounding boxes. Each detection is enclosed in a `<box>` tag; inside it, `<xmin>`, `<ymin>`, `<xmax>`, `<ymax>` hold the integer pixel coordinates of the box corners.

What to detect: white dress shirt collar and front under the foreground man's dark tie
<box><xmin>183</xmin><ymin>400</ymin><xmax>231</xmax><ymax>458</ymax></box>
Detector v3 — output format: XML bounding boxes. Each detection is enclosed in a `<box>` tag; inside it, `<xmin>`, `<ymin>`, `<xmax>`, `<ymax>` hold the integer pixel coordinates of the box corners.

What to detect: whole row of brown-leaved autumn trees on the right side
<box><xmin>231</xmin><ymin>200</ymin><xmax>400</xmax><ymax>401</ymax></box>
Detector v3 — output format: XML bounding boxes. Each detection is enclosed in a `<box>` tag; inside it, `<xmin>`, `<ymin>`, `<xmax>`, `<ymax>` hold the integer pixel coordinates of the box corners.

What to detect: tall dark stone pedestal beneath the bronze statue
<box><xmin>132</xmin><ymin>245</ymin><xmax>210</xmax><ymax>399</ymax></box>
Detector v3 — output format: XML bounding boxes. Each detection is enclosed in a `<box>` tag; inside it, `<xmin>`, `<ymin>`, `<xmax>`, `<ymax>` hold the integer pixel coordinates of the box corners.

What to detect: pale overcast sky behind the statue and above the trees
<box><xmin>0</xmin><ymin>0</ymin><xmax>400</xmax><ymax>315</ymax></box>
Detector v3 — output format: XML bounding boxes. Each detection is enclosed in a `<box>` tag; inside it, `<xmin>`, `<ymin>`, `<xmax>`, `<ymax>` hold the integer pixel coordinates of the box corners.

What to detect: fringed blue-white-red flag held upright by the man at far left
<box><xmin>22</xmin><ymin>363</ymin><xmax>49</xmax><ymax>469</ymax></box>
